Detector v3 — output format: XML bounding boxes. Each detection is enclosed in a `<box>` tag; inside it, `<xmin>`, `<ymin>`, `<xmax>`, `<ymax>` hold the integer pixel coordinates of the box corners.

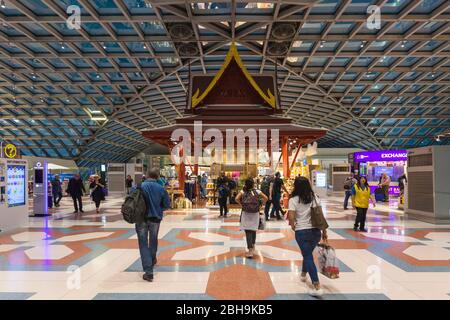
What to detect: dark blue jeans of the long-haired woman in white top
<box><xmin>295</xmin><ymin>228</ymin><xmax>322</xmax><ymax>283</ymax></box>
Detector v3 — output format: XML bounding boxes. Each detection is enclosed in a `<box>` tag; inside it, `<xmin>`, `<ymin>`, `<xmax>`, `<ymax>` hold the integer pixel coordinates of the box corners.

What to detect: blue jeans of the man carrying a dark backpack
<box><xmin>136</xmin><ymin>221</ymin><xmax>160</xmax><ymax>274</ymax></box>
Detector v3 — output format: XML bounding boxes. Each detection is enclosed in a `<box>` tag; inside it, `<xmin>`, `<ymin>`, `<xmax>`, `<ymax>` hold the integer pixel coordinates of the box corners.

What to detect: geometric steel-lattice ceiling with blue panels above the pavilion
<box><xmin>0</xmin><ymin>0</ymin><xmax>450</xmax><ymax>166</ymax></box>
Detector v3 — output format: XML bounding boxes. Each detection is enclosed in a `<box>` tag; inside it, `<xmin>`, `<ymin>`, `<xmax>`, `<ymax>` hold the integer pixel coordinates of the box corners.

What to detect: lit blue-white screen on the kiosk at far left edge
<box><xmin>6</xmin><ymin>165</ymin><xmax>26</xmax><ymax>207</ymax></box>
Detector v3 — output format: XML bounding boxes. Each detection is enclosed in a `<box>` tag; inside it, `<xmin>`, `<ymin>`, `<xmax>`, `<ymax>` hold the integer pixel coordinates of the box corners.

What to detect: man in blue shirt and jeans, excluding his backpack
<box><xmin>136</xmin><ymin>169</ymin><xmax>170</xmax><ymax>282</ymax></box>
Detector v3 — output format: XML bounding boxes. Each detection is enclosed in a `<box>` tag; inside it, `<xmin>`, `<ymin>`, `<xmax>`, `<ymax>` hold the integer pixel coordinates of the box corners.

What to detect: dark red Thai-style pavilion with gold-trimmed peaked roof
<box><xmin>142</xmin><ymin>44</ymin><xmax>326</xmax><ymax>188</ymax></box>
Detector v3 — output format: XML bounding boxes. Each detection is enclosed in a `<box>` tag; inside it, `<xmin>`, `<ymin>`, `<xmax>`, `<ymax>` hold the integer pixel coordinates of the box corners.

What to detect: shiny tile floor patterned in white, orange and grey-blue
<box><xmin>0</xmin><ymin>197</ymin><xmax>450</xmax><ymax>300</ymax></box>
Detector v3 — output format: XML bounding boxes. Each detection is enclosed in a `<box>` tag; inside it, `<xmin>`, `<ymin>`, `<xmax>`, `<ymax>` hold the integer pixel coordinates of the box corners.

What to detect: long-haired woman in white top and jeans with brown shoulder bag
<box><xmin>288</xmin><ymin>177</ymin><xmax>328</xmax><ymax>297</ymax></box>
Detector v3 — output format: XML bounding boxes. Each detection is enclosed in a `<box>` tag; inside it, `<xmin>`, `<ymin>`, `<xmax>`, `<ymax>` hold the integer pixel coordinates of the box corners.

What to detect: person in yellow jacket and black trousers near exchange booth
<box><xmin>352</xmin><ymin>176</ymin><xmax>376</xmax><ymax>232</ymax></box>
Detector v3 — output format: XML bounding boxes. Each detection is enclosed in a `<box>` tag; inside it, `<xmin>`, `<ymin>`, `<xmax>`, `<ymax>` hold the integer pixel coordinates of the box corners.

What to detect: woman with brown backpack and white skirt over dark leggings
<box><xmin>236</xmin><ymin>178</ymin><xmax>268</xmax><ymax>259</ymax></box>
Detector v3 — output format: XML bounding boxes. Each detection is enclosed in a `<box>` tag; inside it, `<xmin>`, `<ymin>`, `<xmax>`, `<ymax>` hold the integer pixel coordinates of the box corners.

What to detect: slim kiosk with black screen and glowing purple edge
<box><xmin>33</xmin><ymin>162</ymin><xmax>49</xmax><ymax>217</ymax></box>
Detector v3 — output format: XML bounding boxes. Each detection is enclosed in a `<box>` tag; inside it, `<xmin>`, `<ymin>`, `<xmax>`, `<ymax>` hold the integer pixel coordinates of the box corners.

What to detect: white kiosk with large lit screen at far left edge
<box><xmin>0</xmin><ymin>159</ymin><xmax>28</xmax><ymax>230</ymax></box>
